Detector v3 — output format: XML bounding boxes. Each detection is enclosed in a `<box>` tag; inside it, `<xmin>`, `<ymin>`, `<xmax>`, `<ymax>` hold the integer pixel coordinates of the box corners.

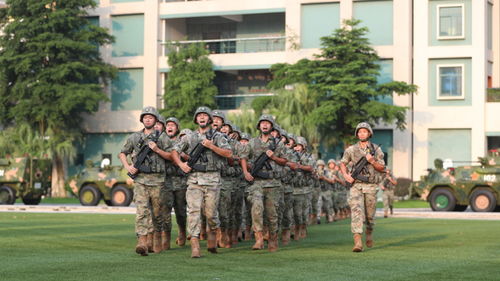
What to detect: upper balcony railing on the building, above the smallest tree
<box><xmin>162</xmin><ymin>36</ymin><xmax>286</xmax><ymax>55</ymax></box>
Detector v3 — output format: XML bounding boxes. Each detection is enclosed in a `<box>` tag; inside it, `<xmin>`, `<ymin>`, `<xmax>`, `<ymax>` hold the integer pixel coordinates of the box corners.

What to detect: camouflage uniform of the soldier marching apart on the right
<box><xmin>341</xmin><ymin>142</ymin><xmax>385</xmax><ymax>234</ymax></box>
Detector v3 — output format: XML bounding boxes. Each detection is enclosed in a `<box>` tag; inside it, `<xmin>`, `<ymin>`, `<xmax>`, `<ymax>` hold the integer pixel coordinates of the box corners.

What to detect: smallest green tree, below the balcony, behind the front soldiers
<box><xmin>161</xmin><ymin>43</ymin><xmax>217</xmax><ymax>128</ymax></box>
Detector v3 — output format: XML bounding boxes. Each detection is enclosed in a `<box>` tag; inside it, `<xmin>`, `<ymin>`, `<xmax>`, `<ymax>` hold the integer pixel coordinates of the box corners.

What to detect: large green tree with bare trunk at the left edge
<box><xmin>0</xmin><ymin>0</ymin><xmax>116</xmax><ymax>196</ymax></box>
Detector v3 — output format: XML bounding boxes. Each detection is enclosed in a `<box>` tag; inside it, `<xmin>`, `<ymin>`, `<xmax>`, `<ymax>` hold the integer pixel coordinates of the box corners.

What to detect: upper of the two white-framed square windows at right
<box><xmin>437</xmin><ymin>4</ymin><xmax>465</xmax><ymax>40</ymax></box>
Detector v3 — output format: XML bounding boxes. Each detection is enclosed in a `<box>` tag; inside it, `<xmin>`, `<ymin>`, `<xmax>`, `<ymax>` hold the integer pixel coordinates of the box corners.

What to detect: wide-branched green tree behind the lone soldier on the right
<box><xmin>269</xmin><ymin>20</ymin><xmax>417</xmax><ymax>143</ymax></box>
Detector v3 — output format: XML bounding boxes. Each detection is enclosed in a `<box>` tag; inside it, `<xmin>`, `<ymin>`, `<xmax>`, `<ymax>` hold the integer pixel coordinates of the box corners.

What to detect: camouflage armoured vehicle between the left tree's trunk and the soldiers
<box><xmin>68</xmin><ymin>159</ymin><xmax>134</xmax><ymax>206</ymax></box>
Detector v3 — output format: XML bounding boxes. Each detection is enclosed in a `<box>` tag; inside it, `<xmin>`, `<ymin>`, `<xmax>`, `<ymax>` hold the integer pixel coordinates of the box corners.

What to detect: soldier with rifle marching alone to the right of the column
<box><xmin>340</xmin><ymin>122</ymin><xmax>385</xmax><ymax>252</ymax></box>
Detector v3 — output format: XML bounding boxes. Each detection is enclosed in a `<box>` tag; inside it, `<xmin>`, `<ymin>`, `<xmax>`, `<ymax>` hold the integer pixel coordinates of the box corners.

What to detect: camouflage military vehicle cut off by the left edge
<box><xmin>0</xmin><ymin>157</ymin><xmax>52</xmax><ymax>205</ymax></box>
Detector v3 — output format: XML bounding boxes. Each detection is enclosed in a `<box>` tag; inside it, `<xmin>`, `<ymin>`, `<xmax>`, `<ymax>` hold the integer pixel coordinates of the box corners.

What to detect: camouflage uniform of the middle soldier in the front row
<box><xmin>174</xmin><ymin>129</ymin><xmax>231</xmax><ymax>238</ymax></box>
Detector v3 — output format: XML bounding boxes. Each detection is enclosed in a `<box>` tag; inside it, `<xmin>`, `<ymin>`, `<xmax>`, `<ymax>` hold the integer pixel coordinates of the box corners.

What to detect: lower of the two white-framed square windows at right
<box><xmin>437</xmin><ymin>64</ymin><xmax>464</xmax><ymax>99</ymax></box>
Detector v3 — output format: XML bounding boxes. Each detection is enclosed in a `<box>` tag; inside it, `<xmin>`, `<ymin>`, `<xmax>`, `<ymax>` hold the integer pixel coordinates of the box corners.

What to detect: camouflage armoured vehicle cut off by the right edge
<box><xmin>412</xmin><ymin>150</ymin><xmax>500</xmax><ymax>212</ymax></box>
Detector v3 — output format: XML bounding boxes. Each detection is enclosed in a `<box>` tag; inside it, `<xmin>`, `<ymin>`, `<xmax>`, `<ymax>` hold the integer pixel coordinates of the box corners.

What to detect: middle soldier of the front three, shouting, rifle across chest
<box><xmin>172</xmin><ymin>106</ymin><xmax>232</xmax><ymax>258</ymax></box>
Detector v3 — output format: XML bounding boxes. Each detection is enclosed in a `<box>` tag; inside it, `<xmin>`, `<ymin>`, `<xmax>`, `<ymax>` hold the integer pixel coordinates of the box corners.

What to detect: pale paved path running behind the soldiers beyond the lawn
<box><xmin>0</xmin><ymin>204</ymin><xmax>500</xmax><ymax>220</ymax></box>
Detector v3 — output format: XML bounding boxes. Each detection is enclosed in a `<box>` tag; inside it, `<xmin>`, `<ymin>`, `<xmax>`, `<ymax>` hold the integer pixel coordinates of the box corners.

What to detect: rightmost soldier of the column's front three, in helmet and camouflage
<box><xmin>239</xmin><ymin>115</ymin><xmax>287</xmax><ymax>252</ymax></box>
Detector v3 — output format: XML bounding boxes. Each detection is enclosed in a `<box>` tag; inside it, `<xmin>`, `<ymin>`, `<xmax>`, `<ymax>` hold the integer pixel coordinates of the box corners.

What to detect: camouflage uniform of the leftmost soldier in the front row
<box><xmin>121</xmin><ymin>130</ymin><xmax>172</xmax><ymax>236</ymax></box>
